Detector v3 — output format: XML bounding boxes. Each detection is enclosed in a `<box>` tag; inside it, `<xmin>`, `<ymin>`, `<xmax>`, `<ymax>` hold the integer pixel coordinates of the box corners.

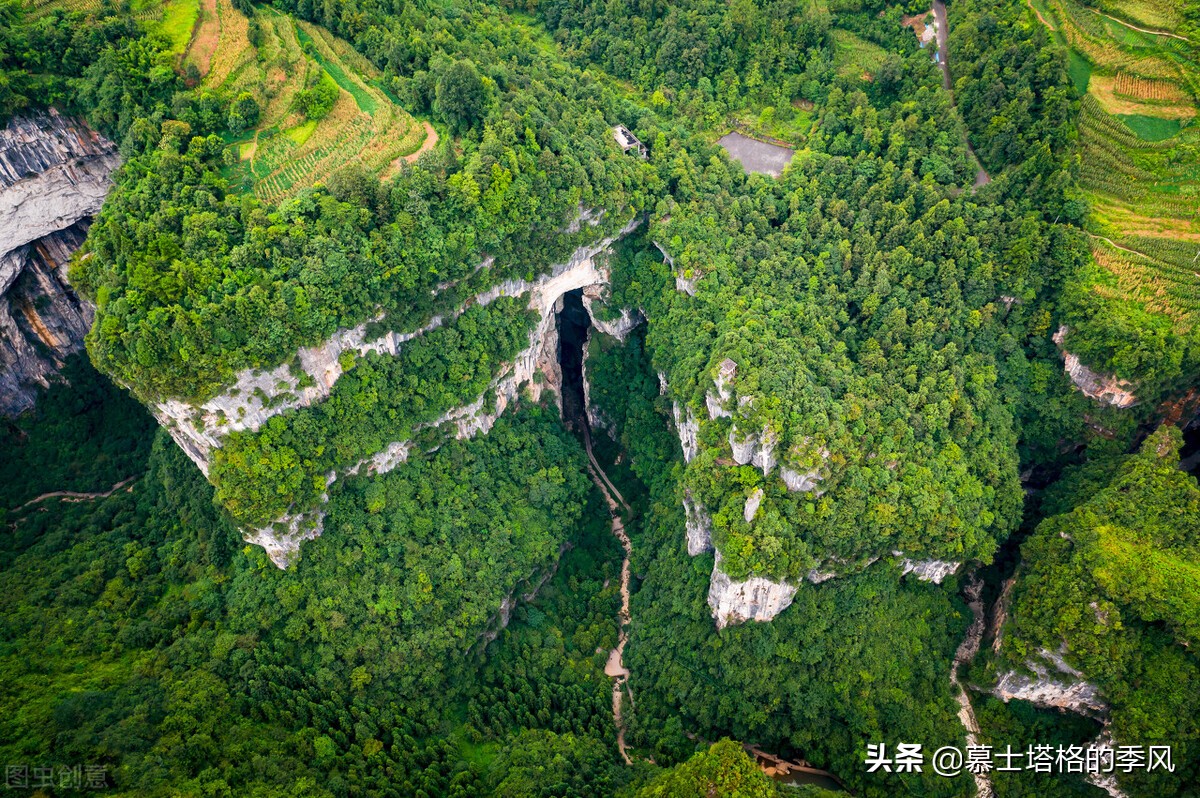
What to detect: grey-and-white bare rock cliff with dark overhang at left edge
<box><xmin>0</xmin><ymin>109</ymin><xmax>120</xmax><ymax>415</ymax></box>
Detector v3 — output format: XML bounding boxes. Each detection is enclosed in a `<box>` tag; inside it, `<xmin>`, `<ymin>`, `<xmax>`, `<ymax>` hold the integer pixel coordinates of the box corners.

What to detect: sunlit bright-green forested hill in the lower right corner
<box><xmin>980</xmin><ymin>427</ymin><xmax>1200</xmax><ymax>794</ymax></box>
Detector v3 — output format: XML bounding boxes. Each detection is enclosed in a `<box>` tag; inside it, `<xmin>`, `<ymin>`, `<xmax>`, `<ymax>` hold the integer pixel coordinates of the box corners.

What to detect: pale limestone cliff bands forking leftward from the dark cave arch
<box><xmin>183</xmin><ymin>220</ymin><xmax>638</xmax><ymax>568</ymax></box>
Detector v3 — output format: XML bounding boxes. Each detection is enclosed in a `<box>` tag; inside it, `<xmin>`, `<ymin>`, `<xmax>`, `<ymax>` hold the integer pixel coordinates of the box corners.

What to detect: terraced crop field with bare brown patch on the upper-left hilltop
<box><xmin>186</xmin><ymin>0</ymin><xmax>426</xmax><ymax>203</ymax></box>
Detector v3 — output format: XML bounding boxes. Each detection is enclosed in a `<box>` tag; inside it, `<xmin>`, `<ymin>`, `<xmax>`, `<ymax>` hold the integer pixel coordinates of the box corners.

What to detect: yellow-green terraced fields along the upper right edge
<box><xmin>1022</xmin><ymin>0</ymin><xmax>1200</xmax><ymax>331</ymax></box>
